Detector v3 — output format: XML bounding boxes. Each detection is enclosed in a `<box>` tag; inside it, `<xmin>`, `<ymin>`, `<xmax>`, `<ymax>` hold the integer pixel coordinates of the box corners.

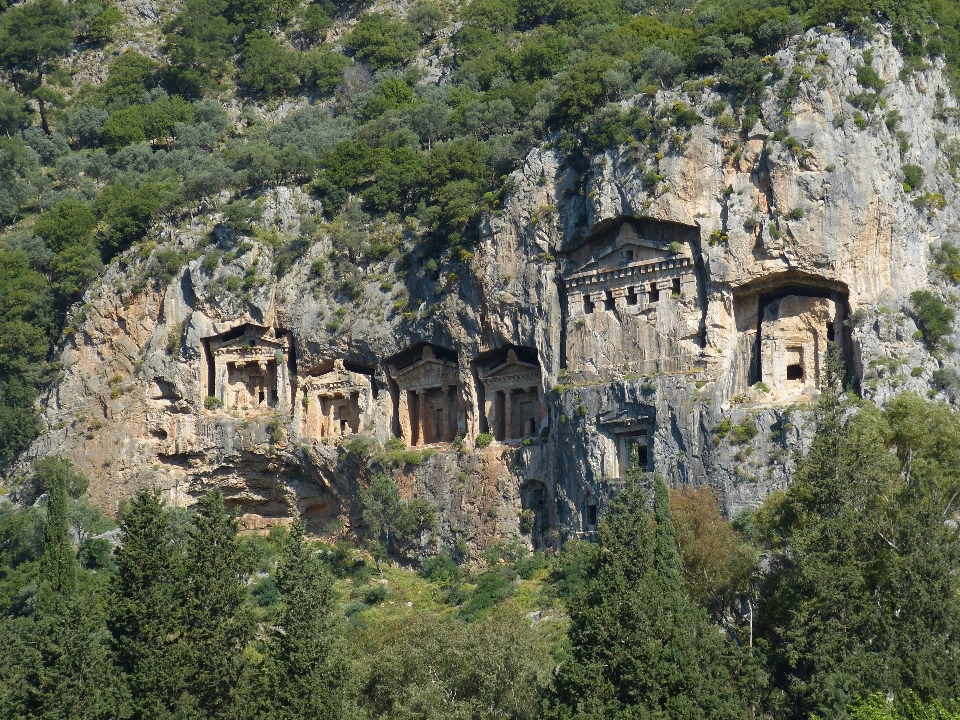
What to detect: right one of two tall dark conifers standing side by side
<box><xmin>183</xmin><ymin>490</ymin><xmax>253</xmax><ymax>718</ymax></box>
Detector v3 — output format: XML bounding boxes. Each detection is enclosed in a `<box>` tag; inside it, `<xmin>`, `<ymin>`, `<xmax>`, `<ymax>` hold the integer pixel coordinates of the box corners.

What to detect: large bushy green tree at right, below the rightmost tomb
<box><xmin>757</xmin><ymin>348</ymin><xmax>960</xmax><ymax>717</ymax></box>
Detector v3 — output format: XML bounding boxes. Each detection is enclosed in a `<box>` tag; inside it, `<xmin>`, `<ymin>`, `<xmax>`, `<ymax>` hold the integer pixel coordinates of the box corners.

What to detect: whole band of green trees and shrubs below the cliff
<box><xmin>0</xmin><ymin>382</ymin><xmax>960</xmax><ymax>720</ymax></box>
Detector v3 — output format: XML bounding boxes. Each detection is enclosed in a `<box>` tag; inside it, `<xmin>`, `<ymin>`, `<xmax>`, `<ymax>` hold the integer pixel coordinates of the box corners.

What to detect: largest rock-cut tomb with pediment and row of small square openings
<box><xmin>563</xmin><ymin>218</ymin><xmax>702</xmax><ymax>376</ymax></box>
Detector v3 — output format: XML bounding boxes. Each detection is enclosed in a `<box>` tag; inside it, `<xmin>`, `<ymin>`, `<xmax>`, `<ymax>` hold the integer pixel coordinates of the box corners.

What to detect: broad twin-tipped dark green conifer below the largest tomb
<box><xmin>548</xmin><ymin>458</ymin><xmax>745</xmax><ymax>720</ymax></box>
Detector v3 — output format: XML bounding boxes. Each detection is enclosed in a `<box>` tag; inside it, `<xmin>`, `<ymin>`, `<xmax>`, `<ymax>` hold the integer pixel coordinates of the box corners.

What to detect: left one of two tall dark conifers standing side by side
<box><xmin>107</xmin><ymin>490</ymin><xmax>185</xmax><ymax>720</ymax></box>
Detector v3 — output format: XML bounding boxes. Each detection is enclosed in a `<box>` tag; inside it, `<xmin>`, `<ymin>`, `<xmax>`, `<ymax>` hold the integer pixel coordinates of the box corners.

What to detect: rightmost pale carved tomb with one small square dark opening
<box><xmin>760</xmin><ymin>295</ymin><xmax>842</xmax><ymax>400</ymax></box>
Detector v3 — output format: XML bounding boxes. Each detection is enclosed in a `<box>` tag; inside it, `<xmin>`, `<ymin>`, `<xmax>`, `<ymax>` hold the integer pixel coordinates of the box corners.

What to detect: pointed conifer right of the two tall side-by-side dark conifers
<box><xmin>267</xmin><ymin>519</ymin><xmax>351</xmax><ymax>720</ymax></box>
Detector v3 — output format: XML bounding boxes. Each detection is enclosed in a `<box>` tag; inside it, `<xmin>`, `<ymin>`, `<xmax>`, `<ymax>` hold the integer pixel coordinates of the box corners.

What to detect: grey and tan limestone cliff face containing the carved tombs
<box><xmin>21</xmin><ymin>31</ymin><xmax>960</xmax><ymax>554</ymax></box>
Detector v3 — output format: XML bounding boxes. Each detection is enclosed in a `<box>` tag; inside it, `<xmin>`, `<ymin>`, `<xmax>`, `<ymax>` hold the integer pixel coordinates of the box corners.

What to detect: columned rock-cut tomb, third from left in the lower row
<box><xmin>388</xmin><ymin>345</ymin><xmax>460</xmax><ymax>447</ymax></box>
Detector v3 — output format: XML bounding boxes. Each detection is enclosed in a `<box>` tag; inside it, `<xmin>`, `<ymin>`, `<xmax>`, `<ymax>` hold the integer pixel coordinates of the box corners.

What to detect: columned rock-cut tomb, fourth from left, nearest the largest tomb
<box><xmin>479</xmin><ymin>350</ymin><xmax>549</xmax><ymax>442</ymax></box>
